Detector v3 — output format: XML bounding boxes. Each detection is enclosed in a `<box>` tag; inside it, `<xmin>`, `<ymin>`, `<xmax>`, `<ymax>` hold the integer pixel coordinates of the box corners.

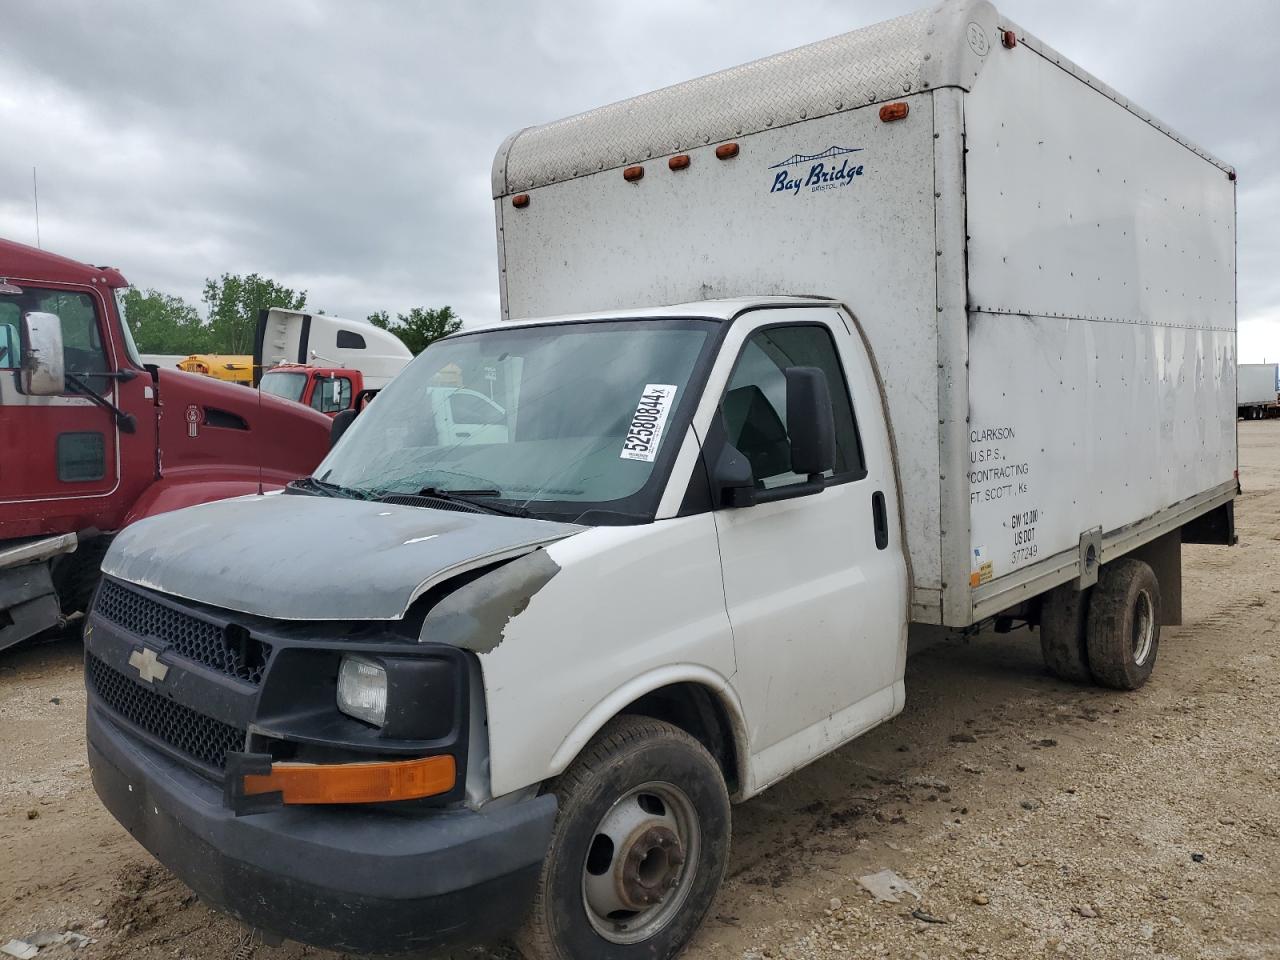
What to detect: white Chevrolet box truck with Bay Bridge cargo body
<box><xmin>86</xmin><ymin>0</ymin><xmax>1236</xmax><ymax>960</ymax></box>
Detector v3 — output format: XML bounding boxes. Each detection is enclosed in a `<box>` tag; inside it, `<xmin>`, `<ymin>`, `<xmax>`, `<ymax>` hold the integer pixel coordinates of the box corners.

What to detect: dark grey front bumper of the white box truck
<box><xmin>87</xmin><ymin>701</ymin><xmax>556</xmax><ymax>954</ymax></box>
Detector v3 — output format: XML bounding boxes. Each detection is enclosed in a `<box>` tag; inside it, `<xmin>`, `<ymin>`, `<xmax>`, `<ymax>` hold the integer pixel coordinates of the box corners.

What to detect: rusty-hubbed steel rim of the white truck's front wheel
<box><xmin>582</xmin><ymin>781</ymin><xmax>701</xmax><ymax>943</ymax></box>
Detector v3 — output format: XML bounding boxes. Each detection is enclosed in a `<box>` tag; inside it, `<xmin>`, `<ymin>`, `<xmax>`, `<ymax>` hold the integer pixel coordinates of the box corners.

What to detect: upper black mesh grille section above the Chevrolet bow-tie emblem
<box><xmin>93</xmin><ymin>580</ymin><xmax>271</xmax><ymax>684</ymax></box>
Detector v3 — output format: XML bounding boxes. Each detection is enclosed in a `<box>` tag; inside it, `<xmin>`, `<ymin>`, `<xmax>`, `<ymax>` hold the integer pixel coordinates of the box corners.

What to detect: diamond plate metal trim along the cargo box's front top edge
<box><xmin>494</xmin><ymin>9</ymin><xmax>936</xmax><ymax>196</ymax></box>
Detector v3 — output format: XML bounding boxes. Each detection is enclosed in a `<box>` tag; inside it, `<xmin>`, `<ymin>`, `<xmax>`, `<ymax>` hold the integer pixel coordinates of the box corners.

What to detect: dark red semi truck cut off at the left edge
<box><xmin>0</xmin><ymin>239</ymin><xmax>332</xmax><ymax>649</ymax></box>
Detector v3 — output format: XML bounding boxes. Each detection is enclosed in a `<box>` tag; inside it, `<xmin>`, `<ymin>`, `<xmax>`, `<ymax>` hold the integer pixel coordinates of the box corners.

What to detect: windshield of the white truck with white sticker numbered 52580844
<box><xmin>315</xmin><ymin>320</ymin><xmax>714</xmax><ymax>506</ymax></box>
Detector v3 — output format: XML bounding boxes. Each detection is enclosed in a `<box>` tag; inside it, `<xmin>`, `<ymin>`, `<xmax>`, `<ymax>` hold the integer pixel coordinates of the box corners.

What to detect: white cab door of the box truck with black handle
<box><xmin>707</xmin><ymin>307</ymin><xmax>908</xmax><ymax>787</ymax></box>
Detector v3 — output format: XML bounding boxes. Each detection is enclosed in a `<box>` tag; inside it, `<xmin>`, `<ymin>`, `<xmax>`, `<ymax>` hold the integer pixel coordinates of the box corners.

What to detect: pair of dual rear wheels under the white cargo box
<box><xmin>1039</xmin><ymin>559</ymin><xmax>1160</xmax><ymax>690</ymax></box>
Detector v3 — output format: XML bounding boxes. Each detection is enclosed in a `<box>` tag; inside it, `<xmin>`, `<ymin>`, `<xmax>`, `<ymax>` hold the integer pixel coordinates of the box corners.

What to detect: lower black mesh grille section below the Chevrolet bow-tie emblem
<box><xmin>86</xmin><ymin>654</ymin><xmax>244</xmax><ymax>769</ymax></box>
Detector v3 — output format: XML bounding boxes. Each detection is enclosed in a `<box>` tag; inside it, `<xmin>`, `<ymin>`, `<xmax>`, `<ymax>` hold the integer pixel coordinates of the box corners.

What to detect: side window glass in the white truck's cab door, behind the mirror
<box><xmin>721</xmin><ymin>324</ymin><xmax>867</xmax><ymax>489</ymax></box>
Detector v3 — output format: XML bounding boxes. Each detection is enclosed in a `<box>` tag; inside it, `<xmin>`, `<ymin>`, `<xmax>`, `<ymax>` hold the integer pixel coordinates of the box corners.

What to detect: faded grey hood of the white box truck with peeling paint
<box><xmin>102</xmin><ymin>494</ymin><xmax>585</xmax><ymax>620</ymax></box>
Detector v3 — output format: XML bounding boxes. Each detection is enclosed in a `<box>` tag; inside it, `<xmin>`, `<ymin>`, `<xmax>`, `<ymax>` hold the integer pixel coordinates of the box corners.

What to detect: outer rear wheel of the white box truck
<box><xmin>1085</xmin><ymin>559</ymin><xmax>1160</xmax><ymax>690</ymax></box>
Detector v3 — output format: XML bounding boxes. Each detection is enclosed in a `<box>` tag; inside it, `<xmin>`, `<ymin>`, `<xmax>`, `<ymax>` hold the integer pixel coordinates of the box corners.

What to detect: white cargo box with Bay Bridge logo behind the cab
<box><xmin>493</xmin><ymin>4</ymin><xmax>1236</xmax><ymax>626</ymax></box>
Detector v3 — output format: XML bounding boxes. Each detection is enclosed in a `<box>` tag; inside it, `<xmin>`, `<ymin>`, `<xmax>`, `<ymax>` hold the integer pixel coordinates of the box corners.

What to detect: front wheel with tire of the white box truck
<box><xmin>517</xmin><ymin>717</ymin><xmax>730</xmax><ymax>960</ymax></box>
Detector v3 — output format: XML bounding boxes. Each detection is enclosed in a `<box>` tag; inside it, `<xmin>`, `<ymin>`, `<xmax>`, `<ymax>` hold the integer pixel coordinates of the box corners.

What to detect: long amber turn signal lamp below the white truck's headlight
<box><xmin>244</xmin><ymin>755</ymin><xmax>457</xmax><ymax>804</ymax></box>
